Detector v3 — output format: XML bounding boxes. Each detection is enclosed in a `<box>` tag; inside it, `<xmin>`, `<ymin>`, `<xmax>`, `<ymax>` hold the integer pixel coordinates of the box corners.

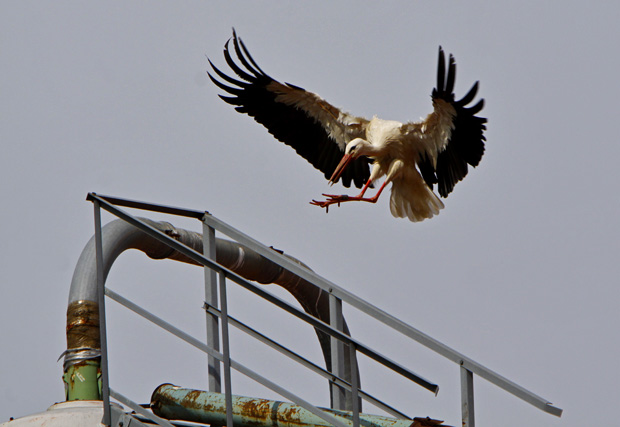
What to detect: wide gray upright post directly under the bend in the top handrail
<box><xmin>202</xmin><ymin>217</ymin><xmax>222</xmax><ymax>393</ymax></box>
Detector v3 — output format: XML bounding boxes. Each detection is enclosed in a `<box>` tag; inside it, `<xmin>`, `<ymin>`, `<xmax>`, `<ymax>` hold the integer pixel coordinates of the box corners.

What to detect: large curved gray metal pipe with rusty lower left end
<box><xmin>64</xmin><ymin>218</ymin><xmax>359</xmax><ymax>407</ymax></box>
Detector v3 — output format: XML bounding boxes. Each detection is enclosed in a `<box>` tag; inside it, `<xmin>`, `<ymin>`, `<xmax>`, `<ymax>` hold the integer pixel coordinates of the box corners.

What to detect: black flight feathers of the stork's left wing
<box><xmin>208</xmin><ymin>30</ymin><xmax>370</xmax><ymax>188</ymax></box>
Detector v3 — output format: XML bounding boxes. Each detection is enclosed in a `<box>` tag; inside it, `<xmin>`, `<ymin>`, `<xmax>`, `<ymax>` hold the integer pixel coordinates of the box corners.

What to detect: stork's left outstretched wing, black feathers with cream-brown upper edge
<box><xmin>209</xmin><ymin>30</ymin><xmax>370</xmax><ymax>187</ymax></box>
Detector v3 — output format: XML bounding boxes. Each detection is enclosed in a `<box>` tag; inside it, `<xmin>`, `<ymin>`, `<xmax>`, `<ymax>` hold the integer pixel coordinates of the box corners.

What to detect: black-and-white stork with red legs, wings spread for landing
<box><xmin>207</xmin><ymin>29</ymin><xmax>487</xmax><ymax>222</ymax></box>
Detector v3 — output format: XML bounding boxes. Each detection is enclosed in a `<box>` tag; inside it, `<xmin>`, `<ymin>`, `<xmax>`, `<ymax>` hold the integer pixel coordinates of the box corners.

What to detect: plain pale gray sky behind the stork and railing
<box><xmin>0</xmin><ymin>1</ymin><xmax>620</xmax><ymax>426</ymax></box>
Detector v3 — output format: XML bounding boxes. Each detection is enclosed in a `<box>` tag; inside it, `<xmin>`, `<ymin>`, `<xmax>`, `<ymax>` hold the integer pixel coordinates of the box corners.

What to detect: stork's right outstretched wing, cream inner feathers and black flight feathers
<box><xmin>416</xmin><ymin>47</ymin><xmax>487</xmax><ymax>197</ymax></box>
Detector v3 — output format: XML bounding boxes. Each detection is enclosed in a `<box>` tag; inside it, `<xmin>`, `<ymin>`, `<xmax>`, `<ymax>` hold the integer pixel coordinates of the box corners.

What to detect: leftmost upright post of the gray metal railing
<box><xmin>93</xmin><ymin>201</ymin><xmax>112</xmax><ymax>426</ymax></box>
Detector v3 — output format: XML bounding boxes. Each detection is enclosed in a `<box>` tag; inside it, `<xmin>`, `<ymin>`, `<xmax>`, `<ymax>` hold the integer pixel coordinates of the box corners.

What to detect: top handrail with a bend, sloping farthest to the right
<box><xmin>87</xmin><ymin>193</ymin><xmax>562</xmax><ymax>417</ymax></box>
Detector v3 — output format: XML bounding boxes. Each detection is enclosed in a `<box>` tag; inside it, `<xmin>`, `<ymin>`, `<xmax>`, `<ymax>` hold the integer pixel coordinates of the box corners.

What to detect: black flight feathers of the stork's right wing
<box><xmin>418</xmin><ymin>47</ymin><xmax>487</xmax><ymax>197</ymax></box>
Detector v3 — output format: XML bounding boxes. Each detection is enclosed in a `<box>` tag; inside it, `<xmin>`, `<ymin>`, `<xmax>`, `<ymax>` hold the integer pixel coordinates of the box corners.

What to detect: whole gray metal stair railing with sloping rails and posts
<box><xmin>87</xmin><ymin>193</ymin><xmax>562</xmax><ymax>427</ymax></box>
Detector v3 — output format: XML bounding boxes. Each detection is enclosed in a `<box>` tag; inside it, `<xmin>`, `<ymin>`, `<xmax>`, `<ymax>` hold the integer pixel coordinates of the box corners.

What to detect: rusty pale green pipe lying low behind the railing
<box><xmin>151</xmin><ymin>384</ymin><xmax>448</xmax><ymax>427</ymax></box>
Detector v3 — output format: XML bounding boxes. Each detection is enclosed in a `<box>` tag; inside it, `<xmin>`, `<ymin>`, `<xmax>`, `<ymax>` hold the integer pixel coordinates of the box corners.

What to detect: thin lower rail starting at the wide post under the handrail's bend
<box><xmin>205</xmin><ymin>303</ymin><xmax>411</xmax><ymax>419</ymax></box>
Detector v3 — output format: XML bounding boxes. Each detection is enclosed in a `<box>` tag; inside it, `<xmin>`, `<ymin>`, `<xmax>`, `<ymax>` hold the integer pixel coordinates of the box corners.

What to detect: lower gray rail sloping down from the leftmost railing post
<box><xmin>105</xmin><ymin>288</ymin><xmax>348</xmax><ymax>427</ymax></box>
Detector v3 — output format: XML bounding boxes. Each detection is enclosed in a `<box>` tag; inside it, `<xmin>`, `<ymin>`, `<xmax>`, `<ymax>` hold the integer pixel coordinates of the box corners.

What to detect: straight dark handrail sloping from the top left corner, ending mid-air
<box><xmin>91</xmin><ymin>193</ymin><xmax>439</xmax><ymax>394</ymax></box>
